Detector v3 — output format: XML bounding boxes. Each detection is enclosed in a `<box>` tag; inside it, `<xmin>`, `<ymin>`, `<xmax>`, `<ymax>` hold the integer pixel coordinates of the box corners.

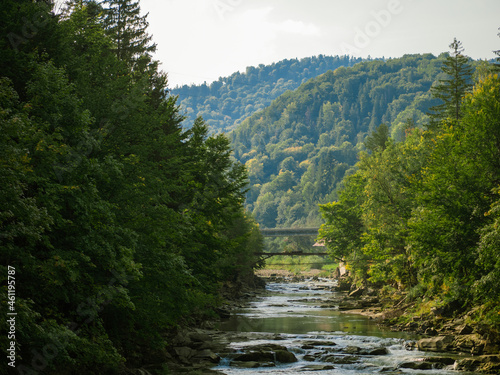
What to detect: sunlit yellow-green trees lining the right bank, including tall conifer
<box><xmin>320</xmin><ymin>40</ymin><xmax>500</xmax><ymax>328</ymax></box>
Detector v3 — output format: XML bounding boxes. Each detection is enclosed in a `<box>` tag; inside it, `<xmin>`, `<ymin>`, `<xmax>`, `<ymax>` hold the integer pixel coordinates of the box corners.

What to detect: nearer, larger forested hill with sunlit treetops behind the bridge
<box><xmin>230</xmin><ymin>54</ymin><xmax>454</xmax><ymax>227</ymax></box>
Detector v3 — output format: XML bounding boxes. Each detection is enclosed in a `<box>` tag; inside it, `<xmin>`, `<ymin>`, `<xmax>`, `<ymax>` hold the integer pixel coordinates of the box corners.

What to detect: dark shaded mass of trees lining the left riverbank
<box><xmin>0</xmin><ymin>0</ymin><xmax>262</xmax><ymax>374</ymax></box>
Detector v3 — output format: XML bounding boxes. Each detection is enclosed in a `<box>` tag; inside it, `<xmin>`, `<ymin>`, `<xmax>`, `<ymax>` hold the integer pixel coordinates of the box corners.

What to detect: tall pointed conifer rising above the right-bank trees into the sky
<box><xmin>430</xmin><ymin>38</ymin><xmax>473</xmax><ymax>127</ymax></box>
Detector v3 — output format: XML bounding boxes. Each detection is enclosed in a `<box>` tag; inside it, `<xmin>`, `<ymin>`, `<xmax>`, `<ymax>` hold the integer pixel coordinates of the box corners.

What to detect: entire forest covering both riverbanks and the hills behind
<box><xmin>0</xmin><ymin>0</ymin><xmax>500</xmax><ymax>375</ymax></box>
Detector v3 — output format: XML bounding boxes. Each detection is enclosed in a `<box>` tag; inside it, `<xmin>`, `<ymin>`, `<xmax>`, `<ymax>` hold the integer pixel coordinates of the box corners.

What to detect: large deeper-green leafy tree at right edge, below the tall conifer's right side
<box><xmin>410</xmin><ymin>77</ymin><xmax>500</xmax><ymax>304</ymax></box>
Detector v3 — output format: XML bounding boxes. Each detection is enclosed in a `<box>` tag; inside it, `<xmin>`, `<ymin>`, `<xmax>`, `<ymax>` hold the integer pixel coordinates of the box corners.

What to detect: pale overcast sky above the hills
<box><xmin>140</xmin><ymin>0</ymin><xmax>500</xmax><ymax>87</ymax></box>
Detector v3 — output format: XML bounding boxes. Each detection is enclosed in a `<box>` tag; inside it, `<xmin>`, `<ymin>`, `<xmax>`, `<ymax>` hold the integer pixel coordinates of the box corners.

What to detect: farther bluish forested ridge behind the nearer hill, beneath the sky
<box><xmin>171</xmin><ymin>55</ymin><xmax>362</xmax><ymax>132</ymax></box>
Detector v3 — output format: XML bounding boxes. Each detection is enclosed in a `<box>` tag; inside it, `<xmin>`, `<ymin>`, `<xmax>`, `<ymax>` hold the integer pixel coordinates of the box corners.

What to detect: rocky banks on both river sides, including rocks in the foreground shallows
<box><xmin>134</xmin><ymin>273</ymin><xmax>500</xmax><ymax>375</ymax></box>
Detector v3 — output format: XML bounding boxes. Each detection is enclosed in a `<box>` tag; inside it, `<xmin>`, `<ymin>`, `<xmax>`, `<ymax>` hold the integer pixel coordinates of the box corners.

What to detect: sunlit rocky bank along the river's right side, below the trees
<box><xmin>326</xmin><ymin>274</ymin><xmax>500</xmax><ymax>374</ymax></box>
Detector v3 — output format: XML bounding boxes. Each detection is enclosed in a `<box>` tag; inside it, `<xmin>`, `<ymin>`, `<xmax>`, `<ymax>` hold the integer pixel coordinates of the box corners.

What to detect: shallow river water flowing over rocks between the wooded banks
<box><xmin>216</xmin><ymin>280</ymin><xmax>470</xmax><ymax>375</ymax></box>
